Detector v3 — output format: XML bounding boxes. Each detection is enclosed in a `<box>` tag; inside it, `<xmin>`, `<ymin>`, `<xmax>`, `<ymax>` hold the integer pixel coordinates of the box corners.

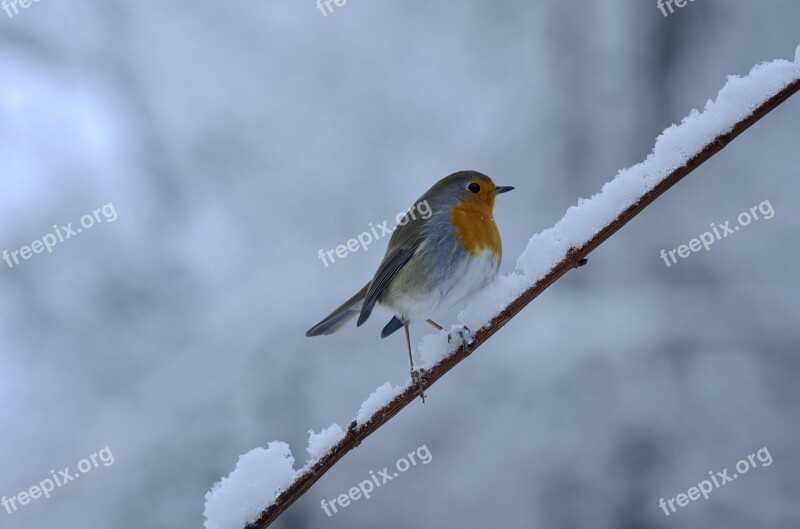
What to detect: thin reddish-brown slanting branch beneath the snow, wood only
<box><xmin>241</xmin><ymin>67</ymin><xmax>800</xmax><ymax>529</ymax></box>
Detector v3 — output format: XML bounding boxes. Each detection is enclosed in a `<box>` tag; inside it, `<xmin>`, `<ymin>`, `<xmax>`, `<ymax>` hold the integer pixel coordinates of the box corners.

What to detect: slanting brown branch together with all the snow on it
<box><xmin>205</xmin><ymin>46</ymin><xmax>800</xmax><ymax>529</ymax></box>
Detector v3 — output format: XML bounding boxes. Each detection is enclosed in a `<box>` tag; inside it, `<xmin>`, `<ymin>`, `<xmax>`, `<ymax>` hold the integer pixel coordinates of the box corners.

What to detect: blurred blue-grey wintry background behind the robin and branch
<box><xmin>0</xmin><ymin>0</ymin><xmax>800</xmax><ymax>529</ymax></box>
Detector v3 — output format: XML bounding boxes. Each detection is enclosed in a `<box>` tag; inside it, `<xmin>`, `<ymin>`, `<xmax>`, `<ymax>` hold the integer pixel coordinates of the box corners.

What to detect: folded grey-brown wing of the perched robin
<box><xmin>356</xmin><ymin>208</ymin><xmax>426</xmax><ymax>326</ymax></box>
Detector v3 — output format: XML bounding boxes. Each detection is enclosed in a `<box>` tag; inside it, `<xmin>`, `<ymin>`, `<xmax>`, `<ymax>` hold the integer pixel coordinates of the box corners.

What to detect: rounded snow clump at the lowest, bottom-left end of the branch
<box><xmin>204</xmin><ymin>441</ymin><xmax>297</xmax><ymax>529</ymax></box>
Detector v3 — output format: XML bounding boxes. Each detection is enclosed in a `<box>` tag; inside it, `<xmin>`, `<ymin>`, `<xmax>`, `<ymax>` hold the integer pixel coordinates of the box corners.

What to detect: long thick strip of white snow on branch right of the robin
<box><xmin>456</xmin><ymin>46</ymin><xmax>800</xmax><ymax>330</ymax></box>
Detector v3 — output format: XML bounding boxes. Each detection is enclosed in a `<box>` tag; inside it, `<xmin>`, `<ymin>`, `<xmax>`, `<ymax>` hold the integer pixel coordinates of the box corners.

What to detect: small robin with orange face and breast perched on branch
<box><xmin>306</xmin><ymin>171</ymin><xmax>514</xmax><ymax>402</ymax></box>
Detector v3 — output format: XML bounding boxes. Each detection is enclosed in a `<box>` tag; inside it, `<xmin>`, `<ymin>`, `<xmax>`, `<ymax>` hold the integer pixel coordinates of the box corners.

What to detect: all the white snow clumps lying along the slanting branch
<box><xmin>205</xmin><ymin>46</ymin><xmax>800</xmax><ymax>529</ymax></box>
